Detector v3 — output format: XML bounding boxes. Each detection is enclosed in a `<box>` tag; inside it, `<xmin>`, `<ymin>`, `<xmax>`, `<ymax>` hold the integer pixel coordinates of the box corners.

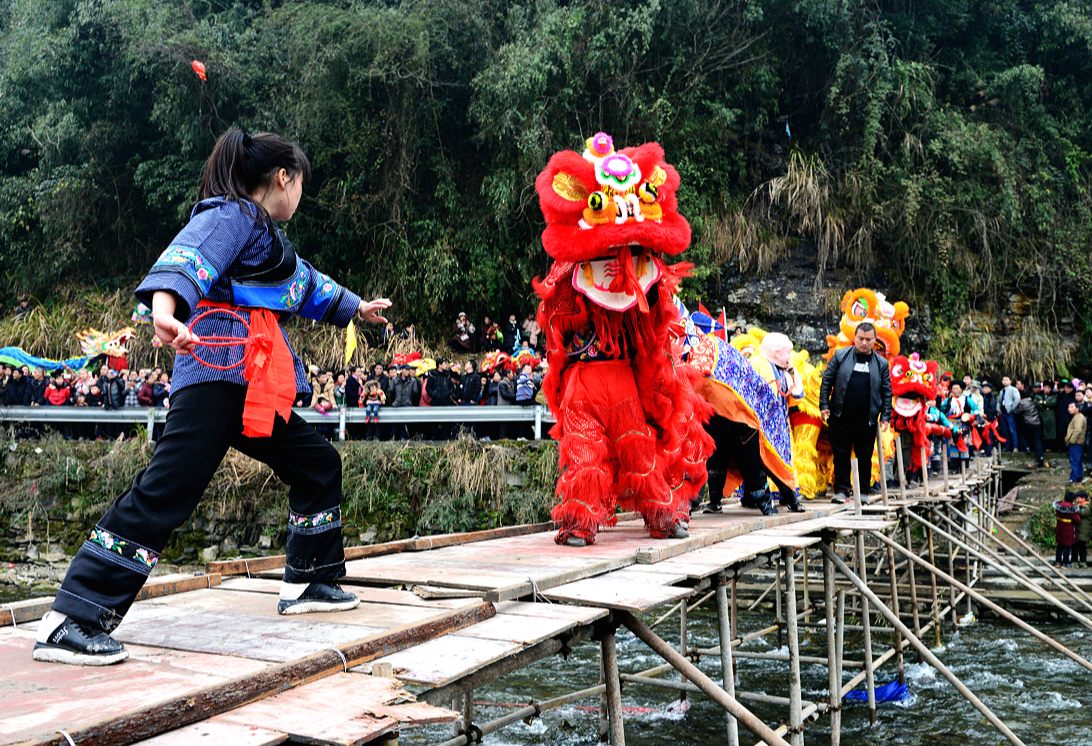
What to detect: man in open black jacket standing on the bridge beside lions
<box><xmin>819</xmin><ymin>321</ymin><xmax>891</xmax><ymax>502</ymax></box>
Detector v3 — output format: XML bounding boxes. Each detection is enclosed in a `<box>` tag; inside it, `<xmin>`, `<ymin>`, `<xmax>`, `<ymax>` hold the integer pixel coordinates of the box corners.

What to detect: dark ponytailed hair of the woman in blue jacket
<box><xmin>199</xmin><ymin>129</ymin><xmax>311</xmax><ymax>229</ymax></box>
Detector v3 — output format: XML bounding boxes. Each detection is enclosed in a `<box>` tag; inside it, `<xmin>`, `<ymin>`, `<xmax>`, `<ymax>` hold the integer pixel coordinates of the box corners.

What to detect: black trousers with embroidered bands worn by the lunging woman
<box><xmin>54</xmin><ymin>381</ymin><xmax>345</xmax><ymax>631</ymax></box>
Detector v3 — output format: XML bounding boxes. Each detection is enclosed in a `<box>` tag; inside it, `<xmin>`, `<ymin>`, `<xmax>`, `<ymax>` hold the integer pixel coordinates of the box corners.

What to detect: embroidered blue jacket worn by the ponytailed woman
<box><xmin>135</xmin><ymin>197</ymin><xmax>360</xmax><ymax>392</ymax></box>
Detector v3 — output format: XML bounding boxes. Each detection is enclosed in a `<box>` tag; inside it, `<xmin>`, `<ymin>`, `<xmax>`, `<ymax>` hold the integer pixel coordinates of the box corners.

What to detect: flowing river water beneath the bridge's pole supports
<box><xmin>400</xmin><ymin>608</ymin><xmax>1092</xmax><ymax>746</ymax></box>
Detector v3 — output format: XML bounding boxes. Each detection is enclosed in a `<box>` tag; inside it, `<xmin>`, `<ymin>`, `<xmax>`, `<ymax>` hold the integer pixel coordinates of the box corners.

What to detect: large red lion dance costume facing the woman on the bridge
<box><xmin>534</xmin><ymin>132</ymin><xmax>713</xmax><ymax>546</ymax></box>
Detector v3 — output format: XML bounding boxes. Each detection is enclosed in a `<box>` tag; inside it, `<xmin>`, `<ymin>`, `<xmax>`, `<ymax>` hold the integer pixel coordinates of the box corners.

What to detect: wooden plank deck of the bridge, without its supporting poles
<box><xmin>0</xmin><ymin>471</ymin><xmax>995</xmax><ymax>746</ymax></box>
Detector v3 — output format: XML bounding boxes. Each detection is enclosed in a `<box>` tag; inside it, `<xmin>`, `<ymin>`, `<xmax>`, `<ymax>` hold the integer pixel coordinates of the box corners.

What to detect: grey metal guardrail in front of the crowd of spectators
<box><xmin>0</xmin><ymin>404</ymin><xmax>554</xmax><ymax>442</ymax></box>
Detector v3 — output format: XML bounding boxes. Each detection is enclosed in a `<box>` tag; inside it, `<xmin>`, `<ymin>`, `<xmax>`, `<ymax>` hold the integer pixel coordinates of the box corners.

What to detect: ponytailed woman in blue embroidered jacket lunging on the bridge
<box><xmin>34</xmin><ymin>130</ymin><xmax>391</xmax><ymax>665</ymax></box>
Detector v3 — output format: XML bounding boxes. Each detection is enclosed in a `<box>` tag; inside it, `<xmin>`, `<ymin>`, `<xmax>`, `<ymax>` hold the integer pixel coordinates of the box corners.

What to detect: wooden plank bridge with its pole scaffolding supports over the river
<box><xmin>0</xmin><ymin>449</ymin><xmax>1092</xmax><ymax>746</ymax></box>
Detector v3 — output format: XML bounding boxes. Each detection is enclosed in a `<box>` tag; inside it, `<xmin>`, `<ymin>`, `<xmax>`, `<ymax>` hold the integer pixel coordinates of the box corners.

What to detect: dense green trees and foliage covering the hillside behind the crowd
<box><xmin>0</xmin><ymin>0</ymin><xmax>1092</xmax><ymax>366</ymax></box>
